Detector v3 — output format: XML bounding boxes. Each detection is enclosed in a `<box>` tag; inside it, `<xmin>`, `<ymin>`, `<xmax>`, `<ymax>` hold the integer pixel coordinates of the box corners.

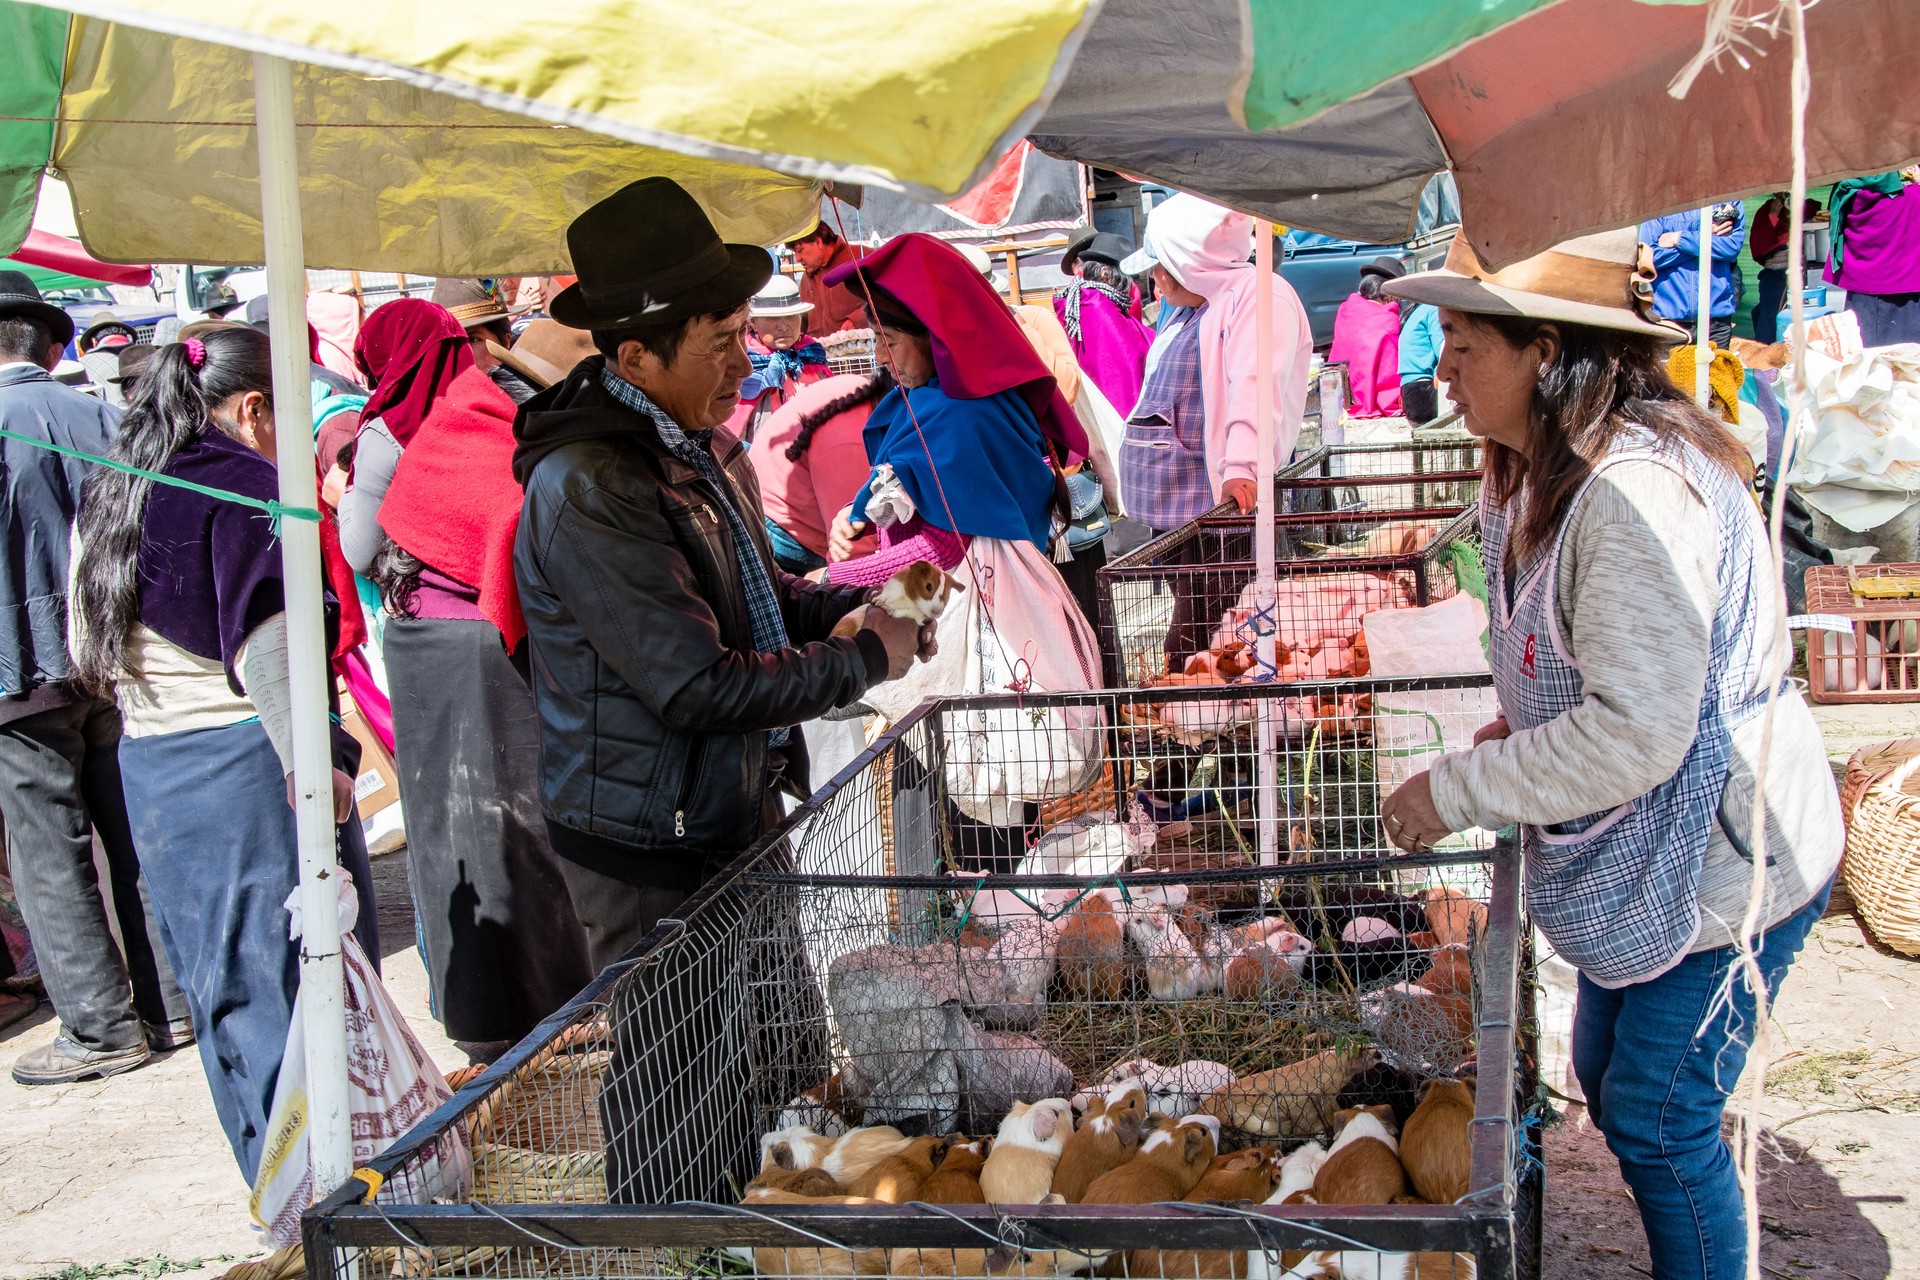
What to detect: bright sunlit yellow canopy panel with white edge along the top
<box><xmin>58</xmin><ymin>0</ymin><xmax>1098</xmax><ymax>198</ymax></box>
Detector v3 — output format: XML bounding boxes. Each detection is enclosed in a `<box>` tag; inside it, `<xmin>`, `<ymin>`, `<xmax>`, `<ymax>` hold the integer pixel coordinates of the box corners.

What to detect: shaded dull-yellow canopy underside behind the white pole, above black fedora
<box><xmin>52</xmin><ymin>19</ymin><xmax>818</xmax><ymax>274</ymax></box>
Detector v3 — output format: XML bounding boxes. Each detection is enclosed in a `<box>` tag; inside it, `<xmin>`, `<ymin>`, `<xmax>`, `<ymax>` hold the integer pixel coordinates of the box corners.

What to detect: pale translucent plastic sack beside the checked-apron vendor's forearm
<box><xmin>1361</xmin><ymin>593</ymin><xmax>1500</xmax><ymax>883</ymax></box>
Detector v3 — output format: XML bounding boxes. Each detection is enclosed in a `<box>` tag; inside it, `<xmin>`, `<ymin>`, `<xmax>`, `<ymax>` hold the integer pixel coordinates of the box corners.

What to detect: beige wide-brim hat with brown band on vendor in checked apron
<box><xmin>1380</xmin><ymin>226</ymin><xmax>1686</xmax><ymax>342</ymax></box>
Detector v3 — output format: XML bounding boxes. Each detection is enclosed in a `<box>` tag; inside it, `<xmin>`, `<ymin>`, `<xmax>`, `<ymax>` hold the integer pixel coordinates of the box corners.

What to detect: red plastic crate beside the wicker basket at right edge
<box><xmin>1807</xmin><ymin>564</ymin><xmax>1920</xmax><ymax>702</ymax></box>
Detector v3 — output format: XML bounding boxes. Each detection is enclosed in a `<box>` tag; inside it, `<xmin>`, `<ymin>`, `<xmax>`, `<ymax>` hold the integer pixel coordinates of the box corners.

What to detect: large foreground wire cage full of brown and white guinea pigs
<box><xmin>305</xmin><ymin>677</ymin><xmax>1540</xmax><ymax>1280</ymax></box>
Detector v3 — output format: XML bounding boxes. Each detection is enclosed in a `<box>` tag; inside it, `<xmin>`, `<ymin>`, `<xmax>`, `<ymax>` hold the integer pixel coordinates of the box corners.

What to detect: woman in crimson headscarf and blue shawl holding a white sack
<box><xmin>826</xmin><ymin>234</ymin><xmax>1100</xmax><ymax>869</ymax></box>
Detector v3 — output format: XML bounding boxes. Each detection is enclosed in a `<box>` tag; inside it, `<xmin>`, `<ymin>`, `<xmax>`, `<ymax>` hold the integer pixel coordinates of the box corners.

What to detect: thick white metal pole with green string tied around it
<box><xmin>253</xmin><ymin>54</ymin><xmax>353</xmax><ymax>1197</ymax></box>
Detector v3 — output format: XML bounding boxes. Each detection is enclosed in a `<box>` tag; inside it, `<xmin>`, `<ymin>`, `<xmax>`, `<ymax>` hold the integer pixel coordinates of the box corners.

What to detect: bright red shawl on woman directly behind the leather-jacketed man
<box><xmin>376</xmin><ymin>368</ymin><xmax>526</xmax><ymax>652</ymax></box>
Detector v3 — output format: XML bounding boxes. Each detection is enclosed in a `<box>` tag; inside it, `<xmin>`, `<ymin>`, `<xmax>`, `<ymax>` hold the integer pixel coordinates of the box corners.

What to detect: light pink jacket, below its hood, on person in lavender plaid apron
<box><xmin>1200</xmin><ymin>265</ymin><xmax>1313</xmax><ymax>501</ymax></box>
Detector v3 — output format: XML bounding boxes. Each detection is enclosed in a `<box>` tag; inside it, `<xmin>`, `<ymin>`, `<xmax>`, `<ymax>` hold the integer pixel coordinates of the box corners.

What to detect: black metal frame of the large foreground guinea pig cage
<box><xmin>314</xmin><ymin>677</ymin><xmax>1544</xmax><ymax>1280</ymax></box>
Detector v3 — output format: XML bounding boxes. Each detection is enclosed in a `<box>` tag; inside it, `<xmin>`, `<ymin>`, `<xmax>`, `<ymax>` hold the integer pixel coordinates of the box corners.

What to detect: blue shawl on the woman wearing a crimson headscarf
<box><xmin>852</xmin><ymin>382</ymin><xmax>1054</xmax><ymax>551</ymax></box>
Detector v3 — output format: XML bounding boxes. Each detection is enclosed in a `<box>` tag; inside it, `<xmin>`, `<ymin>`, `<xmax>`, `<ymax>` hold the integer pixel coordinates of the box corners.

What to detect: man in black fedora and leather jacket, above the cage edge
<box><xmin>515</xmin><ymin>178</ymin><xmax>931</xmax><ymax>967</ymax></box>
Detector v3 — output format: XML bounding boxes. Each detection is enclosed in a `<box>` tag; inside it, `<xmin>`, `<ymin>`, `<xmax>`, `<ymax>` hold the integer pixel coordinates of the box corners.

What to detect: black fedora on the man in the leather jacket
<box><xmin>547</xmin><ymin>178</ymin><xmax>774</xmax><ymax>330</ymax></box>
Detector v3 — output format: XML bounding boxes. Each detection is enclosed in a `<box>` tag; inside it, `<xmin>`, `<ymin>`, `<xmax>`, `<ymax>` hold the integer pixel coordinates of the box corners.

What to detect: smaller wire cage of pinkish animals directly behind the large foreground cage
<box><xmin>1098</xmin><ymin>487</ymin><xmax>1484</xmax><ymax>687</ymax></box>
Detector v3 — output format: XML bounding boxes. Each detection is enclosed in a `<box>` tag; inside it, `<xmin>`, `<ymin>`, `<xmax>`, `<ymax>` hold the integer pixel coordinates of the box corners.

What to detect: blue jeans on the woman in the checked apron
<box><xmin>1572</xmin><ymin>889</ymin><xmax>1826</xmax><ymax>1280</ymax></box>
